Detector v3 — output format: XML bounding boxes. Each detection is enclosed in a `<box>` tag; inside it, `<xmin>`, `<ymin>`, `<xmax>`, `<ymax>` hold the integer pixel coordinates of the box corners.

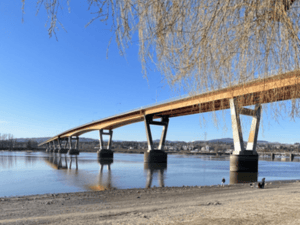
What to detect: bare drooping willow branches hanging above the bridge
<box><xmin>22</xmin><ymin>0</ymin><xmax>300</xmax><ymax>119</ymax></box>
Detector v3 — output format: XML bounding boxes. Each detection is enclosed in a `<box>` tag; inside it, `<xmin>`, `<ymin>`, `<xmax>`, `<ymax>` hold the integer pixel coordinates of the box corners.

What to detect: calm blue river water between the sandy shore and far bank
<box><xmin>0</xmin><ymin>151</ymin><xmax>300</xmax><ymax>197</ymax></box>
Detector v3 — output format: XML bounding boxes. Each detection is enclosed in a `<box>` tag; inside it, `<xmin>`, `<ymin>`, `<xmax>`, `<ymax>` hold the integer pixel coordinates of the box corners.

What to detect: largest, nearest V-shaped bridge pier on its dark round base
<box><xmin>229</xmin><ymin>98</ymin><xmax>261</xmax><ymax>173</ymax></box>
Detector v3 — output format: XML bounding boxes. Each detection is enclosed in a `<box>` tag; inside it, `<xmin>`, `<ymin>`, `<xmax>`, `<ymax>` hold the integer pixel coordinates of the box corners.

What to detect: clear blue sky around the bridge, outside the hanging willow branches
<box><xmin>0</xmin><ymin>0</ymin><xmax>300</xmax><ymax>143</ymax></box>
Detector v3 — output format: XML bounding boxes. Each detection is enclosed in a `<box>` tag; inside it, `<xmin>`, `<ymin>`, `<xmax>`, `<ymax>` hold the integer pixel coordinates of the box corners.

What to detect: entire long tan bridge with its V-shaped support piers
<box><xmin>39</xmin><ymin>71</ymin><xmax>300</xmax><ymax>172</ymax></box>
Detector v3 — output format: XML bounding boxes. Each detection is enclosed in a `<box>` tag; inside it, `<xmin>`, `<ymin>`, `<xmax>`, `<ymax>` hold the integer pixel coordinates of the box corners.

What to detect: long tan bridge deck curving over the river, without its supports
<box><xmin>39</xmin><ymin>71</ymin><xmax>300</xmax><ymax>146</ymax></box>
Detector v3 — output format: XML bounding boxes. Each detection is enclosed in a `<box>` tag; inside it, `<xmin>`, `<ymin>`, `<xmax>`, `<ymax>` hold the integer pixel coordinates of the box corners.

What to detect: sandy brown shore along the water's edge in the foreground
<box><xmin>0</xmin><ymin>181</ymin><xmax>300</xmax><ymax>225</ymax></box>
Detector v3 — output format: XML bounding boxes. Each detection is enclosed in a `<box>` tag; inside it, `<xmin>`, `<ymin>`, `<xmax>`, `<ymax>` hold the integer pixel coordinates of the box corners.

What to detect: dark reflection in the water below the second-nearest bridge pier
<box><xmin>144</xmin><ymin>163</ymin><xmax>167</xmax><ymax>188</ymax></box>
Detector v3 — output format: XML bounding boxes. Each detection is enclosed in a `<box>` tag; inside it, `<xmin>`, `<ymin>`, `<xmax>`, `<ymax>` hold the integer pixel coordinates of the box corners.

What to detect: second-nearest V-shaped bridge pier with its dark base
<box><xmin>144</xmin><ymin>115</ymin><xmax>169</xmax><ymax>163</ymax></box>
